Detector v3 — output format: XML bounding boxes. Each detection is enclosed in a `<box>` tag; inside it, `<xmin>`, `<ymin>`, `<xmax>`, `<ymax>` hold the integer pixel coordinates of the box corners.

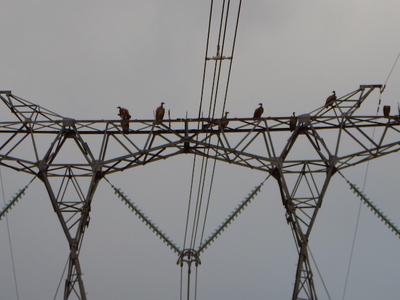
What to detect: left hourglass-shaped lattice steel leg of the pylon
<box><xmin>38</xmin><ymin>120</ymin><xmax>102</xmax><ymax>300</ymax></box>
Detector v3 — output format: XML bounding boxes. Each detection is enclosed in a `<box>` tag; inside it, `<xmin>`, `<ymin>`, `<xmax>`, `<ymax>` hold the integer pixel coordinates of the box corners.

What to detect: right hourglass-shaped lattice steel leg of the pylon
<box><xmin>272</xmin><ymin>121</ymin><xmax>336</xmax><ymax>300</ymax></box>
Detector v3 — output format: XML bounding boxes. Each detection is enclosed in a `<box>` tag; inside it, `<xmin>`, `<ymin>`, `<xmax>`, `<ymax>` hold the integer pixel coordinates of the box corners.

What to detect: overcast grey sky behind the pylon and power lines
<box><xmin>0</xmin><ymin>0</ymin><xmax>400</xmax><ymax>300</ymax></box>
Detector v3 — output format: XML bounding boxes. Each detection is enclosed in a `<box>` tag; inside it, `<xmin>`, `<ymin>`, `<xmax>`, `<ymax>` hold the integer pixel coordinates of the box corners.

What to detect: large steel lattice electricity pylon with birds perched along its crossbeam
<box><xmin>0</xmin><ymin>85</ymin><xmax>400</xmax><ymax>300</ymax></box>
